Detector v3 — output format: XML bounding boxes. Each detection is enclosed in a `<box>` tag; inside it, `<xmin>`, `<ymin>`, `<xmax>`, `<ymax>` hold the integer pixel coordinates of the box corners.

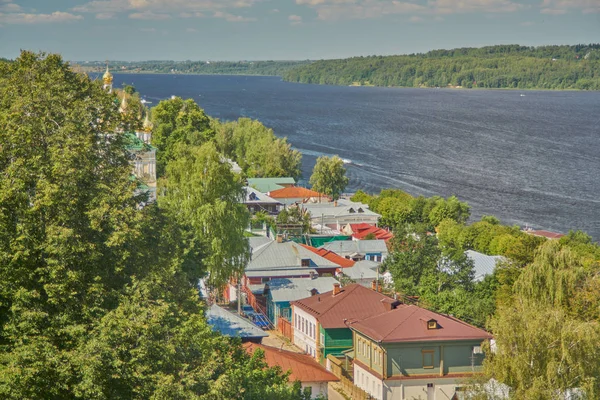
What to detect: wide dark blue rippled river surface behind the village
<box><xmin>115</xmin><ymin>74</ymin><xmax>600</xmax><ymax>240</ymax></box>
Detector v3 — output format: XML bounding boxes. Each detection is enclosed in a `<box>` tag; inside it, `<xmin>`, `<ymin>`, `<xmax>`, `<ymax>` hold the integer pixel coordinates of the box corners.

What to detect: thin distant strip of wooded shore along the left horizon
<box><xmin>77</xmin><ymin>61</ymin><xmax>309</xmax><ymax>76</ymax></box>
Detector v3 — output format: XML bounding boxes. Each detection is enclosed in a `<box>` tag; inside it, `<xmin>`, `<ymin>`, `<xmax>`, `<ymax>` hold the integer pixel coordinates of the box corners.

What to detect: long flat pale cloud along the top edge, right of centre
<box><xmin>296</xmin><ymin>0</ymin><xmax>524</xmax><ymax>20</ymax></box>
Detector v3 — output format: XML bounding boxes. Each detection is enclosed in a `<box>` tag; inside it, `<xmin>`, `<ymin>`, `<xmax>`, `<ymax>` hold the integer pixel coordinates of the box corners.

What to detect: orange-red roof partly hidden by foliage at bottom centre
<box><xmin>242</xmin><ymin>342</ymin><xmax>339</xmax><ymax>382</ymax></box>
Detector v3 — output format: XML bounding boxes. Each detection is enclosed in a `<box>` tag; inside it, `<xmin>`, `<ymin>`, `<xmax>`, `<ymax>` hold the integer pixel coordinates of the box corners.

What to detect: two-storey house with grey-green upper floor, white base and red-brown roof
<box><xmin>349</xmin><ymin>303</ymin><xmax>492</xmax><ymax>400</ymax></box>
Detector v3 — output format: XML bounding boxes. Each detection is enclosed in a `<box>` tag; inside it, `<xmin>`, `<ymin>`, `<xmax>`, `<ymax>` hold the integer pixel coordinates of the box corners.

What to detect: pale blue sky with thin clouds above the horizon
<box><xmin>0</xmin><ymin>0</ymin><xmax>600</xmax><ymax>61</ymax></box>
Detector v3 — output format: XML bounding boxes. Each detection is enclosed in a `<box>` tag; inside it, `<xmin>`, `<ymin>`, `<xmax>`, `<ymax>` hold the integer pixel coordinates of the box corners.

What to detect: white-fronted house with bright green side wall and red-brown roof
<box><xmin>291</xmin><ymin>283</ymin><xmax>393</xmax><ymax>364</ymax></box>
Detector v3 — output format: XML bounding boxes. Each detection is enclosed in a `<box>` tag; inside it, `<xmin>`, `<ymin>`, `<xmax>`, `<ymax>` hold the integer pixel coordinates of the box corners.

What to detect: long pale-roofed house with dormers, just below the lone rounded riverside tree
<box><xmin>301</xmin><ymin>199</ymin><xmax>381</xmax><ymax>233</ymax></box>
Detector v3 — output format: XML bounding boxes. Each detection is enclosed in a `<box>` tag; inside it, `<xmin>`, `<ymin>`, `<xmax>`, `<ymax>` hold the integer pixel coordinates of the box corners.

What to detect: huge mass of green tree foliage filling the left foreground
<box><xmin>0</xmin><ymin>52</ymin><xmax>301</xmax><ymax>400</ymax></box>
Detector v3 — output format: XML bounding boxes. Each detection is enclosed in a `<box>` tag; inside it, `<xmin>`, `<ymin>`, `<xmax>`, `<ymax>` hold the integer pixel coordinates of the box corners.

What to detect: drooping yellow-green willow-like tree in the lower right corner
<box><xmin>484</xmin><ymin>241</ymin><xmax>600</xmax><ymax>400</ymax></box>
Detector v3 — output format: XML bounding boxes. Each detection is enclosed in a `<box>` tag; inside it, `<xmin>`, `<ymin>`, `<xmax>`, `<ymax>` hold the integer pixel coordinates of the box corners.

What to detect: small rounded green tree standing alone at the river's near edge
<box><xmin>309</xmin><ymin>156</ymin><xmax>348</xmax><ymax>200</ymax></box>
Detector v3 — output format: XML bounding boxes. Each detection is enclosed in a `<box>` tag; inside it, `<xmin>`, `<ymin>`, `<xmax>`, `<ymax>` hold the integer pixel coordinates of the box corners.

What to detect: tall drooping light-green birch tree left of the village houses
<box><xmin>159</xmin><ymin>142</ymin><xmax>250</xmax><ymax>285</ymax></box>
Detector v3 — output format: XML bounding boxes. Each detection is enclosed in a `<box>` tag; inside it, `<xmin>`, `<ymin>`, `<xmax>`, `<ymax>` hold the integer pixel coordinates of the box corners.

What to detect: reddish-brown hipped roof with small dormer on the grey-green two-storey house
<box><xmin>351</xmin><ymin>304</ymin><xmax>492</xmax><ymax>343</ymax></box>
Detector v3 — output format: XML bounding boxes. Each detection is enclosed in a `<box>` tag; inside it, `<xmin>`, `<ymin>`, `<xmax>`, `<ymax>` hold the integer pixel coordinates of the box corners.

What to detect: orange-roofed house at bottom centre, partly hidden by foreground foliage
<box><xmin>244</xmin><ymin>343</ymin><xmax>339</xmax><ymax>399</ymax></box>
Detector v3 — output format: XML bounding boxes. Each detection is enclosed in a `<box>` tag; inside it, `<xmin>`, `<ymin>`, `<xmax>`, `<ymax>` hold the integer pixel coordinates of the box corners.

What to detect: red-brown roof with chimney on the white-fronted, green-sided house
<box><xmin>292</xmin><ymin>283</ymin><xmax>393</xmax><ymax>329</ymax></box>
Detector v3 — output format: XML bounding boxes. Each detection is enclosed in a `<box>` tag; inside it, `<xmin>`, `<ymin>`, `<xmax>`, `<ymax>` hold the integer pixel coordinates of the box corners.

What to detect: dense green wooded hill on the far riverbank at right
<box><xmin>283</xmin><ymin>44</ymin><xmax>600</xmax><ymax>90</ymax></box>
